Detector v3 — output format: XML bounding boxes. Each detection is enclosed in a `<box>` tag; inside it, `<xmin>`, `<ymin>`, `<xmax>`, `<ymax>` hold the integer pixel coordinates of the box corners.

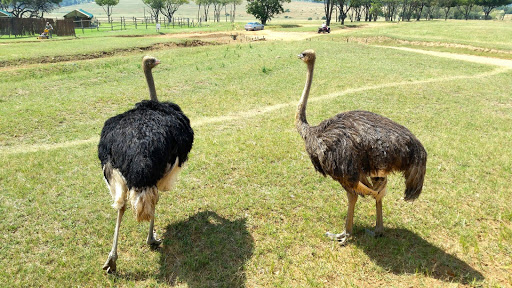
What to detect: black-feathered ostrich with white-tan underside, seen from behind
<box><xmin>98</xmin><ymin>56</ymin><xmax>194</xmax><ymax>273</ymax></box>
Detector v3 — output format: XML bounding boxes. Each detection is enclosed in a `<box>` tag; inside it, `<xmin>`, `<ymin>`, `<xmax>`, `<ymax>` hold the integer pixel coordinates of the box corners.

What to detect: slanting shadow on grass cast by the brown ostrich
<box><xmin>355</xmin><ymin>227</ymin><xmax>484</xmax><ymax>284</ymax></box>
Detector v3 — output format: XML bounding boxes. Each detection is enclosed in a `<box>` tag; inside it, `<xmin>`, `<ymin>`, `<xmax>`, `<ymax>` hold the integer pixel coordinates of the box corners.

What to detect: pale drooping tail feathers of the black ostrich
<box><xmin>130</xmin><ymin>187</ymin><xmax>159</xmax><ymax>222</ymax></box>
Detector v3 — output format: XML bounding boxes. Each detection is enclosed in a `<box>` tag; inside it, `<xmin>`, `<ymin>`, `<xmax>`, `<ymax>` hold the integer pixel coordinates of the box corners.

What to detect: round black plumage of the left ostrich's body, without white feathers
<box><xmin>98</xmin><ymin>100</ymin><xmax>194</xmax><ymax>189</ymax></box>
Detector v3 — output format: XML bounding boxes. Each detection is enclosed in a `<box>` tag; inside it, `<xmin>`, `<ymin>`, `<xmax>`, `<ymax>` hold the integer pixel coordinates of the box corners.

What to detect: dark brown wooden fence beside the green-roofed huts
<box><xmin>0</xmin><ymin>18</ymin><xmax>75</xmax><ymax>37</ymax></box>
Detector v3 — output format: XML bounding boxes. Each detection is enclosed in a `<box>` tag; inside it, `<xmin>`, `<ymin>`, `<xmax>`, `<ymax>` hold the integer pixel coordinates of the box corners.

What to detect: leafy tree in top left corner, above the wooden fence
<box><xmin>0</xmin><ymin>0</ymin><xmax>60</xmax><ymax>18</ymax></box>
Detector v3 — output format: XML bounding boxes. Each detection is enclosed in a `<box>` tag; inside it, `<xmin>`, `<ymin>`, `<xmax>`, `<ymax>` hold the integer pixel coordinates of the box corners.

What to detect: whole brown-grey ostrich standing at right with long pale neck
<box><xmin>295</xmin><ymin>50</ymin><xmax>427</xmax><ymax>245</ymax></box>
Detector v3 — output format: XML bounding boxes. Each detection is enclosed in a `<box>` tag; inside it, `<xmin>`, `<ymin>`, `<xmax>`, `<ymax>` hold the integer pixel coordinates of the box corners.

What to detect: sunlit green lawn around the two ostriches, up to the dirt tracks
<box><xmin>0</xmin><ymin>21</ymin><xmax>512</xmax><ymax>287</ymax></box>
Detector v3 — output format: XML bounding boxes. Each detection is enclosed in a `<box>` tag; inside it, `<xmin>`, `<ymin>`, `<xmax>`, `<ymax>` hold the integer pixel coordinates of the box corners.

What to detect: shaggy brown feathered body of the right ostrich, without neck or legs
<box><xmin>303</xmin><ymin>111</ymin><xmax>427</xmax><ymax>200</ymax></box>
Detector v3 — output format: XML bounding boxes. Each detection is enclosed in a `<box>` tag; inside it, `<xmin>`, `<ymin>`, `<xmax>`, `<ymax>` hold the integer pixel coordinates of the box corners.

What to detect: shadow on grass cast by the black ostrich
<box><xmin>159</xmin><ymin>211</ymin><xmax>254</xmax><ymax>287</ymax></box>
